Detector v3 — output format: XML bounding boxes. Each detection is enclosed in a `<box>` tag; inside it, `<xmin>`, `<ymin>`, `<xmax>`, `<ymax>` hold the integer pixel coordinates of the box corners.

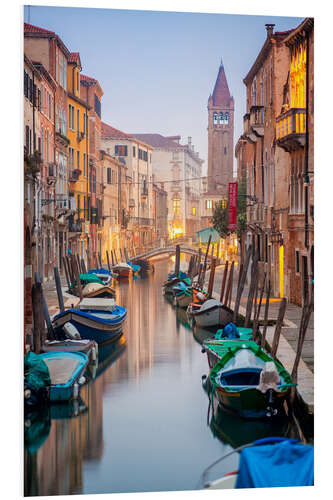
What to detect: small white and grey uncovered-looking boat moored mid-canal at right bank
<box><xmin>188</xmin><ymin>299</ymin><xmax>233</xmax><ymax>328</ymax></box>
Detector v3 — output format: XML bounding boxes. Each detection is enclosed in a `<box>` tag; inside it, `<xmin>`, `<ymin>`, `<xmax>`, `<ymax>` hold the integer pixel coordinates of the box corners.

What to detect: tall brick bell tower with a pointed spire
<box><xmin>207</xmin><ymin>60</ymin><xmax>234</xmax><ymax>195</ymax></box>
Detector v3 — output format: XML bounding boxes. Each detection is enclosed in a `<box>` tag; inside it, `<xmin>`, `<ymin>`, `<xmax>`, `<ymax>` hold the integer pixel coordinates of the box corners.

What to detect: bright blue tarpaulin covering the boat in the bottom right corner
<box><xmin>235</xmin><ymin>439</ymin><xmax>314</xmax><ymax>489</ymax></box>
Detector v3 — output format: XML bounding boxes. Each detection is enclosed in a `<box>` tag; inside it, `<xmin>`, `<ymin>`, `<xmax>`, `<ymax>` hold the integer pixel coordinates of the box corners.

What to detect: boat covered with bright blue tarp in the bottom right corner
<box><xmin>201</xmin><ymin>437</ymin><xmax>314</xmax><ymax>489</ymax></box>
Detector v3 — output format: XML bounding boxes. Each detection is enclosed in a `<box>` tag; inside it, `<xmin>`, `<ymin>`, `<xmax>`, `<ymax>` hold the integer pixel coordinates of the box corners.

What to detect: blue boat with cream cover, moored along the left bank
<box><xmin>53</xmin><ymin>298</ymin><xmax>127</xmax><ymax>344</ymax></box>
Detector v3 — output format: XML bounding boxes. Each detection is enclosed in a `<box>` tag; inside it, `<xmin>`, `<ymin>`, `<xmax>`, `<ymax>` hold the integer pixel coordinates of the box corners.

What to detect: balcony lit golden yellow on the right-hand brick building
<box><xmin>276</xmin><ymin>108</ymin><xmax>306</xmax><ymax>153</ymax></box>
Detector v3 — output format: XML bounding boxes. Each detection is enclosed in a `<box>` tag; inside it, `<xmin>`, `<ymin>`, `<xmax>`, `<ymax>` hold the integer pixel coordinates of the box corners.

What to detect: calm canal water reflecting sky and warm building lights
<box><xmin>24</xmin><ymin>260</ymin><xmax>300</xmax><ymax>496</ymax></box>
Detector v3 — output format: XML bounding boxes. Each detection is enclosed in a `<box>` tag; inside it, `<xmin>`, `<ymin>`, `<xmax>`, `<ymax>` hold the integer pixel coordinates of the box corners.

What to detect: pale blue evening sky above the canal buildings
<box><xmin>24</xmin><ymin>6</ymin><xmax>304</xmax><ymax>173</ymax></box>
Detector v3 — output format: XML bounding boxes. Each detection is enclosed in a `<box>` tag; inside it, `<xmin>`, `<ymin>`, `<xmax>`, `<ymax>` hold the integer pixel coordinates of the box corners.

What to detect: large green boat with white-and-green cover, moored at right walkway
<box><xmin>208</xmin><ymin>340</ymin><xmax>293</xmax><ymax>418</ymax></box>
